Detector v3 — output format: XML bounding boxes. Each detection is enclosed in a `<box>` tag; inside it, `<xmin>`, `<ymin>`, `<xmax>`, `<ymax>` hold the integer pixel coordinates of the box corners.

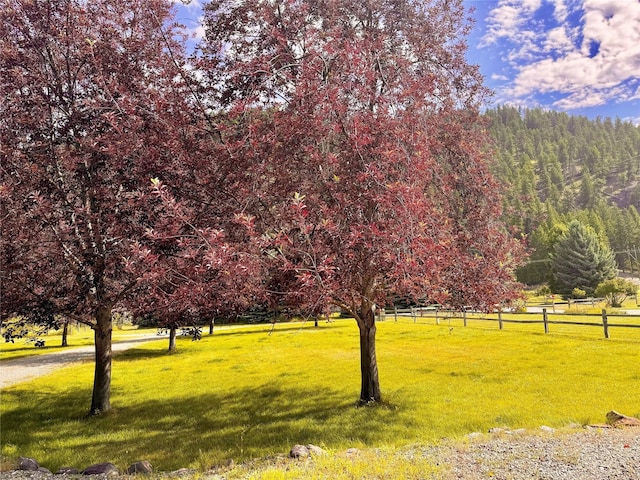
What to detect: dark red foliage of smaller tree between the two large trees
<box><xmin>131</xmin><ymin>179</ymin><xmax>262</xmax><ymax>328</ymax></box>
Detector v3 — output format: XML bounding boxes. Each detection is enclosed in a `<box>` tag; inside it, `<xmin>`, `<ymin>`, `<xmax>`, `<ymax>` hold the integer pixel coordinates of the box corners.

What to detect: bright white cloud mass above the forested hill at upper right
<box><xmin>484</xmin><ymin>0</ymin><xmax>640</xmax><ymax>109</ymax></box>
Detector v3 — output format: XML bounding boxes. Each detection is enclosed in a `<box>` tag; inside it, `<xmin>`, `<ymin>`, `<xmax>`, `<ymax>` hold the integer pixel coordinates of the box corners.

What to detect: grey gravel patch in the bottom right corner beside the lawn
<box><xmin>425</xmin><ymin>427</ymin><xmax>640</xmax><ymax>480</ymax></box>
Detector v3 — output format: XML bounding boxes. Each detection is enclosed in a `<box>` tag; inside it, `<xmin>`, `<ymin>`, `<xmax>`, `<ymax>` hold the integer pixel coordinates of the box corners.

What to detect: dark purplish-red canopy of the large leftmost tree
<box><xmin>0</xmin><ymin>0</ymin><xmax>190</xmax><ymax>324</ymax></box>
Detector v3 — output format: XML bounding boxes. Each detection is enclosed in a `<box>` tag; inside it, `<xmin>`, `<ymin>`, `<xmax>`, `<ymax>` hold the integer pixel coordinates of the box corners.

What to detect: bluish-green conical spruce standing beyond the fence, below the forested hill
<box><xmin>551</xmin><ymin>220</ymin><xmax>617</xmax><ymax>295</ymax></box>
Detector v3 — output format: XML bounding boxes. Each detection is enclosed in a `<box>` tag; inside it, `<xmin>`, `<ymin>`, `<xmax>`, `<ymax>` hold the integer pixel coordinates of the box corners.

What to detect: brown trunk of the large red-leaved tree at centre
<box><xmin>358</xmin><ymin>309</ymin><xmax>382</xmax><ymax>405</ymax></box>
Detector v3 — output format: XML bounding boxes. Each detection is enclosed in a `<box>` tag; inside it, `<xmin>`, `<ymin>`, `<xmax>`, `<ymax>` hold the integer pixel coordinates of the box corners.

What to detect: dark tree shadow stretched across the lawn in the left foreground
<box><xmin>2</xmin><ymin>378</ymin><xmax>398</xmax><ymax>471</ymax></box>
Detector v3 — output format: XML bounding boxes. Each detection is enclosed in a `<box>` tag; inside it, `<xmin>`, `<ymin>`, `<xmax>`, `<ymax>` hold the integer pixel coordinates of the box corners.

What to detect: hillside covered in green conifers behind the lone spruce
<box><xmin>486</xmin><ymin>107</ymin><xmax>640</xmax><ymax>284</ymax></box>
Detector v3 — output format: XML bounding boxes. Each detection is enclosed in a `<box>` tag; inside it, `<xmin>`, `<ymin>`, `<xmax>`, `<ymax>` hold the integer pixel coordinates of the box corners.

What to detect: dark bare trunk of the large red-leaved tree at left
<box><xmin>89</xmin><ymin>305</ymin><xmax>113</xmax><ymax>415</ymax></box>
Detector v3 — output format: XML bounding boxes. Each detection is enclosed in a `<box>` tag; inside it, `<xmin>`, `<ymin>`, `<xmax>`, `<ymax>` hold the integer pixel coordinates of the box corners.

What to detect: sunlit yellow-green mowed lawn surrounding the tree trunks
<box><xmin>0</xmin><ymin>317</ymin><xmax>640</xmax><ymax>471</ymax></box>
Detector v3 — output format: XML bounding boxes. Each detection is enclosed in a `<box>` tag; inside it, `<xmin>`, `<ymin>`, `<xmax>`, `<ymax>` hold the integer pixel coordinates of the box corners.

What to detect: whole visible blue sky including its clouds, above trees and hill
<box><xmin>174</xmin><ymin>0</ymin><xmax>640</xmax><ymax>125</ymax></box>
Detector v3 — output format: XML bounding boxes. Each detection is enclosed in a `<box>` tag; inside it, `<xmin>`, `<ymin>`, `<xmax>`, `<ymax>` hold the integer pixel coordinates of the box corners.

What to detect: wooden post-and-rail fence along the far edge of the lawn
<box><xmin>378</xmin><ymin>307</ymin><xmax>640</xmax><ymax>338</ymax></box>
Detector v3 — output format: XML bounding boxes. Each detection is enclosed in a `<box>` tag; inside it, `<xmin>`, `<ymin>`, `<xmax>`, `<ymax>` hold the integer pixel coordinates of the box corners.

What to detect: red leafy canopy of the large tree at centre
<box><xmin>203</xmin><ymin>0</ymin><xmax>520</xmax><ymax>321</ymax></box>
